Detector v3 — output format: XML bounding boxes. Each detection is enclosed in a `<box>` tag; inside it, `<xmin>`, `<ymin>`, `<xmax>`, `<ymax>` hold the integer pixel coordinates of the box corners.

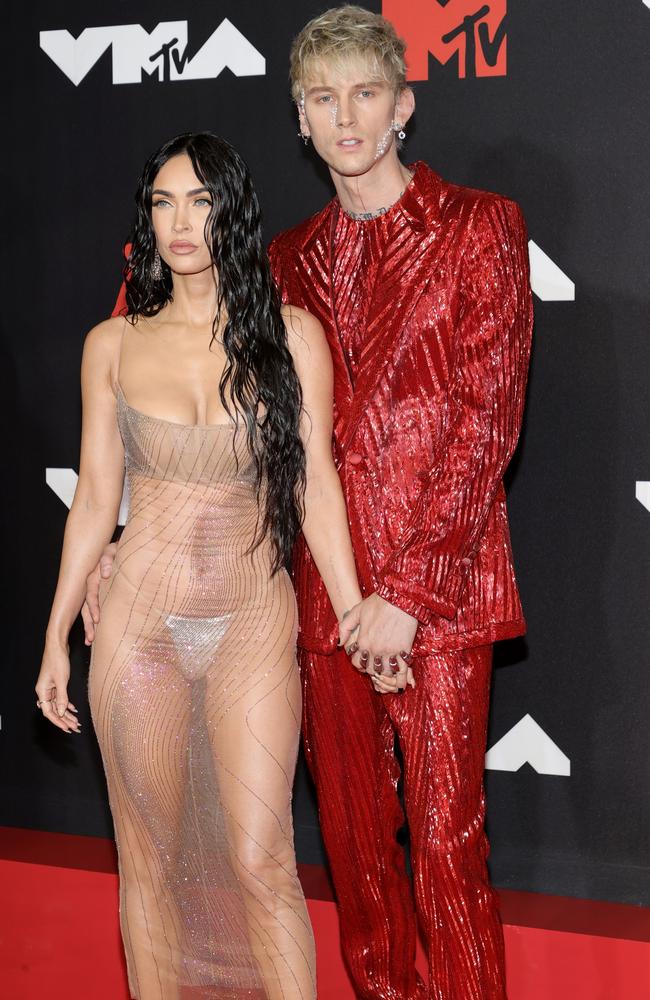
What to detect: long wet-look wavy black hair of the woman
<box><xmin>124</xmin><ymin>132</ymin><xmax>305</xmax><ymax>573</ymax></box>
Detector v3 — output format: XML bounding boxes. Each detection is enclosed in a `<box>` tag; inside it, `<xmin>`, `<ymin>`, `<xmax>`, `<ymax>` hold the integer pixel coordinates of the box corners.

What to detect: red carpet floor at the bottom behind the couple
<box><xmin>0</xmin><ymin>827</ymin><xmax>650</xmax><ymax>1000</ymax></box>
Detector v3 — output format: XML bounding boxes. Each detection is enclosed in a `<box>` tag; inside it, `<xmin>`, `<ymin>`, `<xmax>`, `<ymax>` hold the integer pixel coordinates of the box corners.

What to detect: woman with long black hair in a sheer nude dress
<box><xmin>36</xmin><ymin>133</ymin><xmax>361</xmax><ymax>1000</ymax></box>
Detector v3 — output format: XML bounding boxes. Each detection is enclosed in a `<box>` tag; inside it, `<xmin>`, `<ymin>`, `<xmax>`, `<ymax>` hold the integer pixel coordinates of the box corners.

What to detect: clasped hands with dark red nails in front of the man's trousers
<box><xmin>340</xmin><ymin>594</ymin><xmax>418</xmax><ymax>694</ymax></box>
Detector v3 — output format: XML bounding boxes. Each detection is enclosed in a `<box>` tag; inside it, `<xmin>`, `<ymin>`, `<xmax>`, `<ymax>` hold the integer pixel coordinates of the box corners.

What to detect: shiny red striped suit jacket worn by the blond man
<box><xmin>269</xmin><ymin>163</ymin><xmax>532</xmax><ymax>654</ymax></box>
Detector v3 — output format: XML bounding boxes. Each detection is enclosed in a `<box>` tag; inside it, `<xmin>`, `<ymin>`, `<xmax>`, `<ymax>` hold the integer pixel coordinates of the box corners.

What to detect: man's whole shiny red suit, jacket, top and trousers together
<box><xmin>271</xmin><ymin>163</ymin><xmax>532</xmax><ymax>1000</ymax></box>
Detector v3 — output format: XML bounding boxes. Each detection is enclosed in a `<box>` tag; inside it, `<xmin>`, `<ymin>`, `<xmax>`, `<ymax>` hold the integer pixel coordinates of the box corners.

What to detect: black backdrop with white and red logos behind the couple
<box><xmin>0</xmin><ymin>0</ymin><xmax>650</xmax><ymax>904</ymax></box>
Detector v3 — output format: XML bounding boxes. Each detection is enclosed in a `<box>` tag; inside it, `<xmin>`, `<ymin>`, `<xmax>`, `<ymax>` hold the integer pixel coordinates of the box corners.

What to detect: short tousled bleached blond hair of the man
<box><xmin>290</xmin><ymin>4</ymin><xmax>407</xmax><ymax>104</ymax></box>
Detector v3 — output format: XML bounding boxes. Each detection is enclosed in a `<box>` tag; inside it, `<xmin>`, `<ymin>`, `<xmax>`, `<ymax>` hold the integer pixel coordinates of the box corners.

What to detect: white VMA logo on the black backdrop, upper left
<box><xmin>39</xmin><ymin>18</ymin><xmax>266</xmax><ymax>87</ymax></box>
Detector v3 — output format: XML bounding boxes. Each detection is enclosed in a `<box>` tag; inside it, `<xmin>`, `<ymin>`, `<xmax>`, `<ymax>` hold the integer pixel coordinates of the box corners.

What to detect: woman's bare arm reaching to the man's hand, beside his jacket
<box><xmin>282</xmin><ymin>306</ymin><xmax>361</xmax><ymax>619</ymax></box>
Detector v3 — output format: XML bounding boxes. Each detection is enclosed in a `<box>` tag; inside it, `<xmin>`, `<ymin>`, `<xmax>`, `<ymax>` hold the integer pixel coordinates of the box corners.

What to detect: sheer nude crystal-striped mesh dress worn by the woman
<box><xmin>90</xmin><ymin>372</ymin><xmax>315</xmax><ymax>1000</ymax></box>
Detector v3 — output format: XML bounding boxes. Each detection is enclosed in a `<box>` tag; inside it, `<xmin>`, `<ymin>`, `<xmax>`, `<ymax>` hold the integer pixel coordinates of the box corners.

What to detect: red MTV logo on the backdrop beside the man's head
<box><xmin>382</xmin><ymin>0</ymin><xmax>506</xmax><ymax>80</ymax></box>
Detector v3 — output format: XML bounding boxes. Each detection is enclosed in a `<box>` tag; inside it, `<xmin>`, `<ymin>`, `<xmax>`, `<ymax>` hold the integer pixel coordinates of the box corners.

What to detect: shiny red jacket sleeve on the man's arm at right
<box><xmin>377</xmin><ymin>197</ymin><xmax>532</xmax><ymax>623</ymax></box>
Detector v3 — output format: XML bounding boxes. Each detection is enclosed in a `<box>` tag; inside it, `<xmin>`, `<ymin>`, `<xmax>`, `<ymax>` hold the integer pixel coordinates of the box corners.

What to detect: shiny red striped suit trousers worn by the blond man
<box><xmin>301</xmin><ymin>646</ymin><xmax>506</xmax><ymax>1000</ymax></box>
